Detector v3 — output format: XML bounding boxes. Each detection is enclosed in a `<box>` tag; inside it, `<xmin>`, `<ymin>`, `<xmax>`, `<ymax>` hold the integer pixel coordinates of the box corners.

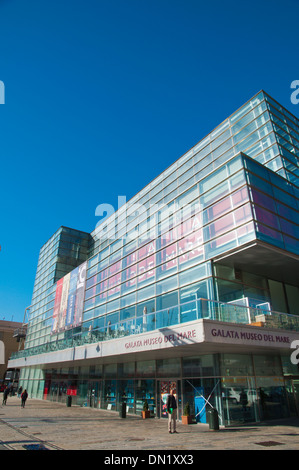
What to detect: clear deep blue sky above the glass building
<box><xmin>0</xmin><ymin>0</ymin><xmax>299</xmax><ymax>321</ymax></box>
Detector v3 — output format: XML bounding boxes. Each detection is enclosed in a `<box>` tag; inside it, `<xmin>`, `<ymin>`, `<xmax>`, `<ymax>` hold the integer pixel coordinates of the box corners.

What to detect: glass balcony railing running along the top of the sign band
<box><xmin>11</xmin><ymin>299</ymin><xmax>299</xmax><ymax>359</ymax></box>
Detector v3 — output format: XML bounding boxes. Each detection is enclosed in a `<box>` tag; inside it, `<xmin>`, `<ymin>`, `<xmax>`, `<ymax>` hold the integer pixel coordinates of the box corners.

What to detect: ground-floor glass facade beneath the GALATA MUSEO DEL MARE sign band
<box><xmin>23</xmin><ymin>354</ymin><xmax>299</xmax><ymax>426</ymax></box>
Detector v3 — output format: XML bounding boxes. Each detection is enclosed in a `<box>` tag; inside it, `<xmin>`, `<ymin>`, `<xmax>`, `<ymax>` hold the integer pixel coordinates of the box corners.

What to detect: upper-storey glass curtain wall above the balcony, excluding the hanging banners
<box><xmin>21</xmin><ymin>92</ymin><xmax>299</xmax><ymax>390</ymax></box>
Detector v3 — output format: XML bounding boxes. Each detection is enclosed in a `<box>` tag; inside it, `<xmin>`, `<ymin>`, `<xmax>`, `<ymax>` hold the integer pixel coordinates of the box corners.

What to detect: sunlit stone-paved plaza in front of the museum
<box><xmin>0</xmin><ymin>397</ymin><xmax>299</xmax><ymax>452</ymax></box>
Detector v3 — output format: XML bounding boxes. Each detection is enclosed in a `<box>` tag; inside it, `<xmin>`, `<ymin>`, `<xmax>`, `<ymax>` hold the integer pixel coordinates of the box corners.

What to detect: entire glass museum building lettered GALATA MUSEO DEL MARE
<box><xmin>9</xmin><ymin>91</ymin><xmax>299</xmax><ymax>426</ymax></box>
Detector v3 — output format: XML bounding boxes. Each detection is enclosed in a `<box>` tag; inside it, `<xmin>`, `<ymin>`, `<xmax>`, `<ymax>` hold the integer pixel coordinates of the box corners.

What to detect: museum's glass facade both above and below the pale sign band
<box><xmin>12</xmin><ymin>91</ymin><xmax>299</xmax><ymax>424</ymax></box>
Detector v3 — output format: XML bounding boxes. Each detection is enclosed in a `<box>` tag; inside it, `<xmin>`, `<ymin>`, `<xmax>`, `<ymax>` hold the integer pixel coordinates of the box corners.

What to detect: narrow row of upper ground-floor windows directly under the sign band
<box><xmin>21</xmin><ymin>354</ymin><xmax>292</xmax><ymax>379</ymax></box>
